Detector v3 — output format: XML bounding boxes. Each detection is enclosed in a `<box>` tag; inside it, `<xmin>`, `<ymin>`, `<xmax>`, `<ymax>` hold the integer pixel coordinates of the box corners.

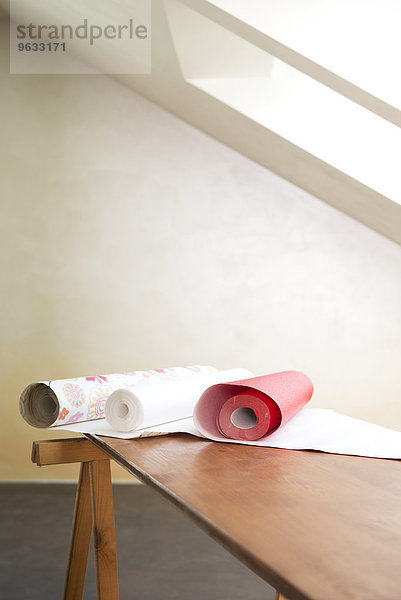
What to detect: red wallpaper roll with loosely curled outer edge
<box><xmin>194</xmin><ymin>371</ymin><xmax>313</xmax><ymax>441</ymax></box>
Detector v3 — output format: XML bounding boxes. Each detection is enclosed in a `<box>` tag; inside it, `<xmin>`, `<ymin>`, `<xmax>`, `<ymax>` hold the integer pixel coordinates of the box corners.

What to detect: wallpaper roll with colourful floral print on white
<box><xmin>19</xmin><ymin>365</ymin><xmax>217</xmax><ymax>427</ymax></box>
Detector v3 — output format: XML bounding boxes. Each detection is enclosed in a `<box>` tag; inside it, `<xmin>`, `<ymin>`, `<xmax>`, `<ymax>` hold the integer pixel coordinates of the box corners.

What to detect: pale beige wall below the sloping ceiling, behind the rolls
<box><xmin>0</xmin><ymin>21</ymin><xmax>401</xmax><ymax>480</ymax></box>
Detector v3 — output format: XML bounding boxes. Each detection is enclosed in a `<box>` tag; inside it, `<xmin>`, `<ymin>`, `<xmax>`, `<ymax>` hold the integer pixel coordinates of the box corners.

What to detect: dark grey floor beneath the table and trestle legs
<box><xmin>0</xmin><ymin>483</ymin><xmax>274</xmax><ymax>600</ymax></box>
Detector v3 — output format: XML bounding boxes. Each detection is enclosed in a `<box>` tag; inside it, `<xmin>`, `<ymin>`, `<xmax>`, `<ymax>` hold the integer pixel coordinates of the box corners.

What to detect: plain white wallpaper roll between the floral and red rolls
<box><xmin>105</xmin><ymin>369</ymin><xmax>252</xmax><ymax>431</ymax></box>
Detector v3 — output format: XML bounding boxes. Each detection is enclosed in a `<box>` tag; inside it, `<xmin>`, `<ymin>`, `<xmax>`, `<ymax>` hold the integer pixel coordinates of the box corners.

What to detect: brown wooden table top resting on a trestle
<box><xmin>87</xmin><ymin>434</ymin><xmax>401</xmax><ymax>600</ymax></box>
